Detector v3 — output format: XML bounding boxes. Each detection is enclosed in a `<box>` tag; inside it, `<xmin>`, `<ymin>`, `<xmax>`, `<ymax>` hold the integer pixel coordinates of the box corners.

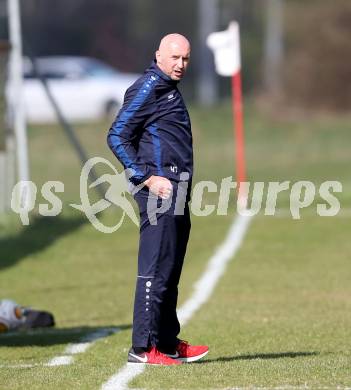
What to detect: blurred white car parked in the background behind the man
<box><xmin>23</xmin><ymin>56</ymin><xmax>140</xmax><ymax>123</ymax></box>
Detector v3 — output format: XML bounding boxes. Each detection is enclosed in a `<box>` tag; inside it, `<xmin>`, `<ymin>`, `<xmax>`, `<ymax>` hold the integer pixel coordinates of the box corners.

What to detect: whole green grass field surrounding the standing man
<box><xmin>0</xmin><ymin>104</ymin><xmax>351</xmax><ymax>390</ymax></box>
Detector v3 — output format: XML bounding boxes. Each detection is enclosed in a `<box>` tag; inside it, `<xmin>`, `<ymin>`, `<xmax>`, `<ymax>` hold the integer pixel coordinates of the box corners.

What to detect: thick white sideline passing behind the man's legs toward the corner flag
<box><xmin>101</xmin><ymin>215</ymin><xmax>252</xmax><ymax>390</ymax></box>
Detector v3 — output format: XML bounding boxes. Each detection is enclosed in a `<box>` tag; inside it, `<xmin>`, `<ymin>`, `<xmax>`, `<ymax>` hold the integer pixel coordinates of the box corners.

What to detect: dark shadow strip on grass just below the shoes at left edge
<box><xmin>0</xmin><ymin>324</ymin><xmax>132</xmax><ymax>348</ymax></box>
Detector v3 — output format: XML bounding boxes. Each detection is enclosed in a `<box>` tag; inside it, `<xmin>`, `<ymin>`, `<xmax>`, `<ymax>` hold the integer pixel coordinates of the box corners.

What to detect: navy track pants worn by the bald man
<box><xmin>132</xmin><ymin>182</ymin><xmax>191</xmax><ymax>352</ymax></box>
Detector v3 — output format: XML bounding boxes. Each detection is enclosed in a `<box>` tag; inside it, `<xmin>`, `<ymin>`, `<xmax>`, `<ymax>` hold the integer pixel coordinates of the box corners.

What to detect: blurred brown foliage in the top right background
<box><xmin>285</xmin><ymin>0</ymin><xmax>351</xmax><ymax>110</ymax></box>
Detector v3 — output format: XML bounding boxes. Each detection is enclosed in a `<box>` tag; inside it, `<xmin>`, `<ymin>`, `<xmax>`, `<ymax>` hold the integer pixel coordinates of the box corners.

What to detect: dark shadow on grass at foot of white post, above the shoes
<box><xmin>0</xmin><ymin>217</ymin><xmax>88</xmax><ymax>271</ymax></box>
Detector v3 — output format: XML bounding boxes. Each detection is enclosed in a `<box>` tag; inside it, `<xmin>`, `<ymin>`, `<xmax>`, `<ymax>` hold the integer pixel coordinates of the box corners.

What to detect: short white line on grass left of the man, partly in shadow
<box><xmin>45</xmin><ymin>328</ymin><xmax>120</xmax><ymax>367</ymax></box>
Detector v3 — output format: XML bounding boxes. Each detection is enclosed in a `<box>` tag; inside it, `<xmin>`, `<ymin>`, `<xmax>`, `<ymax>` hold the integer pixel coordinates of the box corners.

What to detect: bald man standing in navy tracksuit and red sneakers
<box><xmin>107</xmin><ymin>34</ymin><xmax>208</xmax><ymax>365</ymax></box>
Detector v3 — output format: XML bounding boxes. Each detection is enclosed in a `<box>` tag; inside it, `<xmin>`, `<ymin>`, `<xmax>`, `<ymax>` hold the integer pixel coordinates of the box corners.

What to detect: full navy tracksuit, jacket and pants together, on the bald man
<box><xmin>108</xmin><ymin>60</ymin><xmax>193</xmax><ymax>352</ymax></box>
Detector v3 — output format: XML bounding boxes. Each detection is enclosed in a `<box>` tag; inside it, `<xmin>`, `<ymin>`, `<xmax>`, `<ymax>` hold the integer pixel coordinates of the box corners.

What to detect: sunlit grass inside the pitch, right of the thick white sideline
<box><xmin>131</xmin><ymin>217</ymin><xmax>351</xmax><ymax>389</ymax></box>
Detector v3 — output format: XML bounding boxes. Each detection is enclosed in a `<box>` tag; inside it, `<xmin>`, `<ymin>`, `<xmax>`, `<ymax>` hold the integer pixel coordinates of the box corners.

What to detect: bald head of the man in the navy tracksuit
<box><xmin>156</xmin><ymin>34</ymin><xmax>190</xmax><ymax>81</ymax></box>
